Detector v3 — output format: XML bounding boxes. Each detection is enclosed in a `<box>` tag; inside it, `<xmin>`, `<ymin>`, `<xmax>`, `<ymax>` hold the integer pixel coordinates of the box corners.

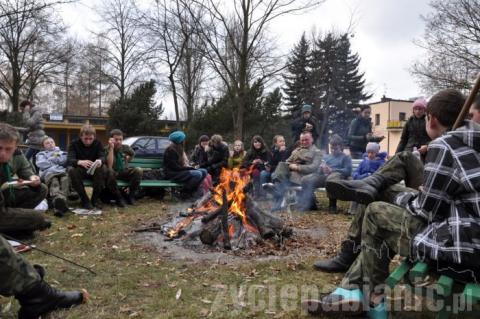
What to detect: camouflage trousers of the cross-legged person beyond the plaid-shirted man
<box><xmin>347</xmin><ymin>151</ymin><xmax>423</xmax><ymax>243</ymax></box>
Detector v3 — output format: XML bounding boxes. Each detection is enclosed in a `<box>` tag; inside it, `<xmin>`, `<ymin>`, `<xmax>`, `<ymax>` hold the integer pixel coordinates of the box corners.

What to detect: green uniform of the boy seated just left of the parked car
<box><xmin>105</xmin><ymin>145</ymin><xmax>142</xmax><ymax>194</ymax></box>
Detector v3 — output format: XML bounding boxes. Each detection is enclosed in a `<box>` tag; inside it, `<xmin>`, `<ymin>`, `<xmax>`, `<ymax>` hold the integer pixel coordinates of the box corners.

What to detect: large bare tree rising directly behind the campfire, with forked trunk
<box><xmin>189</xmin><ymin>0</ymin><xmax>323</xmax><ymax>138</ymax></box>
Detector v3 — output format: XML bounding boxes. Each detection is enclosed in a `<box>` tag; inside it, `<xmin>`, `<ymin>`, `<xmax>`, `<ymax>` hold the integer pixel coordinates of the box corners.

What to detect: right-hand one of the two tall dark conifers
<box><xmin>310</xmin><ymin>33</ymin><xmax>372</xmax><ymax>141</ymax></box>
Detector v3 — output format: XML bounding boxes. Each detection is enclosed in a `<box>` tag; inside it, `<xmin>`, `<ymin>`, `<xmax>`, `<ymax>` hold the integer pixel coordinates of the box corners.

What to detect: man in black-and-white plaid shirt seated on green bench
<box><xmin>303</xmin><ymin>90</ymin><xmax>480</xmax><ymax>318</ymax></box>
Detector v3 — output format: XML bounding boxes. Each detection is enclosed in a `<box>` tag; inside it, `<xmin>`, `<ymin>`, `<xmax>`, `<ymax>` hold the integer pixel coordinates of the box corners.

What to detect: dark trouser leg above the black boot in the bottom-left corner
<box><xmin>0</xmin><ymin>236</ymin><xmax>40</xmax><ymax>296</ymax></box>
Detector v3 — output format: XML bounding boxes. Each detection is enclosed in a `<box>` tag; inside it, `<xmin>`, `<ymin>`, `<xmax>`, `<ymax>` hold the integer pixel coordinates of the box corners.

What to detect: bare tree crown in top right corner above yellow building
<box><xmin>411</xmin><ymin>0</ymin><xmax>480</xmax><ymax>93</ymax></box>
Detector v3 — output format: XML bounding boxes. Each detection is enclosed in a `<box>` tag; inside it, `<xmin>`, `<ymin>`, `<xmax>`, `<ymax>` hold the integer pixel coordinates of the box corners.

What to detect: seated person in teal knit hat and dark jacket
<box><xmin>163</xmin><ymin>131</ymin><xmax>208</xmax><ymax>197</ymax></box>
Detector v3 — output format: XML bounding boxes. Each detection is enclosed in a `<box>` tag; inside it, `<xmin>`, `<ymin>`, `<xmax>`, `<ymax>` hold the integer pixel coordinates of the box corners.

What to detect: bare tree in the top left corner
<box><xmin>0</xmin><ymin>0</ymin><xmax>68</xmax><ymax>111</ymax></box>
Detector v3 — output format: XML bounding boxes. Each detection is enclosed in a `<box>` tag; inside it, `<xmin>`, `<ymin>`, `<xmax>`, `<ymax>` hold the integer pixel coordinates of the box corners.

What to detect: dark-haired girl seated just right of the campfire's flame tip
<box><xmin>242</xmin><ymin>135</ymin><xmax>272</xmax><ymax>197</ymax></box>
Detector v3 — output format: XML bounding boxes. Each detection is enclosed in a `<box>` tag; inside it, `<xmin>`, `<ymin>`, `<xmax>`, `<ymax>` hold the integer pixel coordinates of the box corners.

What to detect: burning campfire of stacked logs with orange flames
<box><xmin>161</xmin><ymin>168</ymin><xmax>292</xmax><ymax>249</ymax></box>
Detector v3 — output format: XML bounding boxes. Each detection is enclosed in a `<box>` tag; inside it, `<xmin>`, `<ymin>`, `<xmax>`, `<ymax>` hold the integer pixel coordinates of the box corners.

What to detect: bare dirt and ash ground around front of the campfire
<box><xmin>134</xmin><ymin>199</ymin><xmax>349</xmax><ymax>264</ymax></box>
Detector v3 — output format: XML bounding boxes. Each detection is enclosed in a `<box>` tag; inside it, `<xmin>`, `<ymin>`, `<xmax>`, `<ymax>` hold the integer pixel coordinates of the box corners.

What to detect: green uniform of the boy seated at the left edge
<box><xmin>0</xmin><ymin>150</ymin><xmax>47</xmax><ymax>232</ymax></box>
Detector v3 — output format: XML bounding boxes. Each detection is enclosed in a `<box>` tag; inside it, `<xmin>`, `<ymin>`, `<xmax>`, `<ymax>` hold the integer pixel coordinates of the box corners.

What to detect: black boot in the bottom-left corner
<box><xmin>15</xmin><ymin>280</ymin><xmax>88</xmax><ymax>319</ymax></box>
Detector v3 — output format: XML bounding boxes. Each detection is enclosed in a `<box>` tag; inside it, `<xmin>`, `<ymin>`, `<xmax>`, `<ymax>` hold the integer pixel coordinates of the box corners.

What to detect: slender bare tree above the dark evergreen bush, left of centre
<box><xmin>97</xmin><ymin>0</ymin><xmax>150</xmax><ymax>99</ymax></box>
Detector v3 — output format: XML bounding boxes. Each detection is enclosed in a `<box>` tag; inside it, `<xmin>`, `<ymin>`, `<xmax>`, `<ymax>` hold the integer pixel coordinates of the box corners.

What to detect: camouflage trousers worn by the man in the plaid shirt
<box><xmin>340</xmin><ymin>202</ymin><xmax>426</xmax><ymax>292</ymax></box>
